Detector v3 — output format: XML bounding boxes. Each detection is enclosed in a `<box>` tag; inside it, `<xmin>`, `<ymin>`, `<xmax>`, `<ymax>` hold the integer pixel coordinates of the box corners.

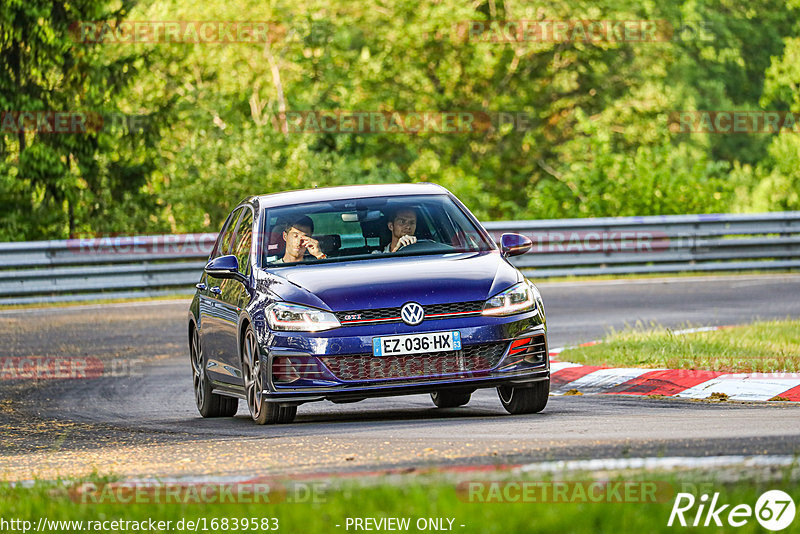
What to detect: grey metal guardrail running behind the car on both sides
<box><xmin>0</xmin><ymin>211</ymin><xmax>800</xmax><ymax>304</ymax></box>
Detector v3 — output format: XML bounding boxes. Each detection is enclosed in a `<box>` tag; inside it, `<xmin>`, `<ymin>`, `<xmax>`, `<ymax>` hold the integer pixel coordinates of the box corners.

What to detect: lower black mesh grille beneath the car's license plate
<box><xmin>320</xmin><ymin>343</ymin><xmax>507</xmax><ymax>381</ymax></box>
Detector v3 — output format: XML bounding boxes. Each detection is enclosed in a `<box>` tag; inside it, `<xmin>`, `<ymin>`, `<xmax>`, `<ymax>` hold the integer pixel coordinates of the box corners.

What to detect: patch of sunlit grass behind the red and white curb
<box><xmin>559</xmin><ymin>319</ymin><xmax>800</xmax><ymax>373</ymax></box>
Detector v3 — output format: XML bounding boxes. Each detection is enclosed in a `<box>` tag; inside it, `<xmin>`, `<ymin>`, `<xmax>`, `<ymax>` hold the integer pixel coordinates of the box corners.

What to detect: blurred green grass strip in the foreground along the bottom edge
<box><xmin>0</xmin><ymin>474</ymin><xmax>800</xmax><ymax>534</ymax></box>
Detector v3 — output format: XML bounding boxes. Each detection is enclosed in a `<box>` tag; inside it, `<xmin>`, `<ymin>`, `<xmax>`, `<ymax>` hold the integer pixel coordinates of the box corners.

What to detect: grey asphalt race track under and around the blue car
<box><xmin>0</xmin><ymin>275</ymin><xmax>800</xmax><ymax>480</ymax></box>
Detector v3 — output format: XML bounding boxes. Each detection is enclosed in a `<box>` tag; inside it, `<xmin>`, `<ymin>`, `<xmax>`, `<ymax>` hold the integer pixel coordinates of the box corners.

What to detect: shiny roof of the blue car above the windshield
<box><xmin>256</xmin><ymin>183</ymin><xmax>449</xmax><ymax>208</ymax></box>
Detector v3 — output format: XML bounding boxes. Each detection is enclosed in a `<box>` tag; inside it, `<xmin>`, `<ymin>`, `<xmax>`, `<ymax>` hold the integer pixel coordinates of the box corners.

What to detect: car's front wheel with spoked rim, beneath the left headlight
<box><xmin>242</xmin><ymin>326</ymin><xmax>297</xmax><ymax>425</ymax></box>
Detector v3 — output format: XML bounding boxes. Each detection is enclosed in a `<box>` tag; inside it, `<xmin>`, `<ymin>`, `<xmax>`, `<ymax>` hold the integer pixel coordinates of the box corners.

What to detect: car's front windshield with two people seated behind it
<box><xmin>261</xmin><ymin>195</ymin><xmax>494</xmax><ymax>267</ymax></box>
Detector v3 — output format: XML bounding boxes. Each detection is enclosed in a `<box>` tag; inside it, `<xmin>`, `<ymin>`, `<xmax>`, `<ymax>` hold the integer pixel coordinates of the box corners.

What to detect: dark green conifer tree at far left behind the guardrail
<box><xmin>0</xmin><ymin>0</ymin><xmax>166</xmax><ymax>239</ymax></box>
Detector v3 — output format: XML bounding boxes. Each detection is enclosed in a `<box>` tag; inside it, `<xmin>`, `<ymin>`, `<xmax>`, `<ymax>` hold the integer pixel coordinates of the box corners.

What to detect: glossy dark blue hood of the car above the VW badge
<box><xmin>268</xmin><ymin>251</ymin><xmax>522</xmax><ymax>311</ymax></box>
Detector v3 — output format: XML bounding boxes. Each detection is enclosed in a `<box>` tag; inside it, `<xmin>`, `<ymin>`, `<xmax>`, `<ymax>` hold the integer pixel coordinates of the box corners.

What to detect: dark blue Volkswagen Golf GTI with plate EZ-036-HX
<box><xmin>188</xmin><ymin>184</ymin><xmax>550</xmax><ymax>424</ymax></box>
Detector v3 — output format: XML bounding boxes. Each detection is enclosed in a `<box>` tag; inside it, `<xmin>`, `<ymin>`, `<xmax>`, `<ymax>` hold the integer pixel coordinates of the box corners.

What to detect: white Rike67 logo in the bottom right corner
<box><xmin>667</xmin><ymin>490</ymin><xmax>795</xmax><ymax>531</ymax></box>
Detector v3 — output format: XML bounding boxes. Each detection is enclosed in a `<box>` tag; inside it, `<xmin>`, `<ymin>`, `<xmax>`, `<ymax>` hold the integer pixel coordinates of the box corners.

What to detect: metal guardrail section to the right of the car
<box><xmin>484</xmin><ymin>211</ymin><xmax>800</xmax><ymax>278</ymax></box>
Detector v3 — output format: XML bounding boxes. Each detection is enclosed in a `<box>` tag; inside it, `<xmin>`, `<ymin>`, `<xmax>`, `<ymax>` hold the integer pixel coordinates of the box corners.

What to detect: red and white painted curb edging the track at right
<box><xmin>550</xmin><ymin>327</ymin><xmax>800</xmax><ymax>402</ymax></box>
